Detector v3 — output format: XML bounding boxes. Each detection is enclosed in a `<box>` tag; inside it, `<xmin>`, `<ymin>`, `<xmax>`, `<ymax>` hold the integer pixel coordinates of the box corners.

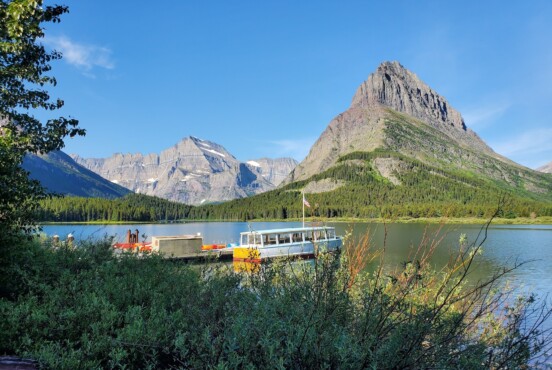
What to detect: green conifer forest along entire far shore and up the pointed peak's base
<box><xmin>38</xmin><ymin>153</ymin><xmax>552</xmax><ymax>222</ymax></box>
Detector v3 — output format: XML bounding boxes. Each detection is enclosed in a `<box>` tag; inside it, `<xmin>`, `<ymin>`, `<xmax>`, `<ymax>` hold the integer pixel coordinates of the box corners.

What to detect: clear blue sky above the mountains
<box><xmin>41</xmin><ymin>0</ymin><xmax>552</xmax><ymax>168</ymax></box>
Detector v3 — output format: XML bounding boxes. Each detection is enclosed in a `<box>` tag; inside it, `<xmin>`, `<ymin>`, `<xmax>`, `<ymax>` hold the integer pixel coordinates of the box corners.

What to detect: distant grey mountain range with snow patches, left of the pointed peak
<box><xmin>72</xmin><ymin>136</ymin><xmax>297</xmax><ymax>205</ymax></box>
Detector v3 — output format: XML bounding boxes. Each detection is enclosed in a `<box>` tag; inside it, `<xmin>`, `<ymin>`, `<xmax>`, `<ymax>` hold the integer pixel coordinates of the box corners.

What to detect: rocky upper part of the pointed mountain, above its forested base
<box><xmin>284</xmin><ymin>62</ymin><xmax>548</xmax><ymax>197</ymax></box>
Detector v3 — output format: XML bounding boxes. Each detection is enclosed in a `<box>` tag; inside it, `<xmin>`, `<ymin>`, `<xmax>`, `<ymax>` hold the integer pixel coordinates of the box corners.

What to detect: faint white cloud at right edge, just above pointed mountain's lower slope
<box><xmin>493</xmin><ymin>128</ymin><xmax>552</xmax><ymax>156</ymax></box>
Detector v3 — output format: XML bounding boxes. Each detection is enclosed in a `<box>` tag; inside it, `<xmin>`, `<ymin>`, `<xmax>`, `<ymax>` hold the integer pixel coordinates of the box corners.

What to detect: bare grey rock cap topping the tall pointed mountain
<box><xmin>352</xmin><ymin>61</ymin><xmax>467</xmax><ymax>136</ymax></box>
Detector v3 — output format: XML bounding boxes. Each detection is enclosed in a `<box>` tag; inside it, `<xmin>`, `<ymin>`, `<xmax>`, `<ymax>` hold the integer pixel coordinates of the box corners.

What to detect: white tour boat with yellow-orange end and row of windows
<box><xmin>233</xmin><ymin>226</ymin><xmax>343</xmax><ymax>263</ymax></box>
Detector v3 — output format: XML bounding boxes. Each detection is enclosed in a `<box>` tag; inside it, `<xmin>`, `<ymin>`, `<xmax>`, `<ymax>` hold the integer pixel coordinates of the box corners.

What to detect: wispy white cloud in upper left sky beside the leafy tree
<box><xmin>44</xmin><ymin>36</ymin><xmax>115</xmax><ymax>73</ymax></box>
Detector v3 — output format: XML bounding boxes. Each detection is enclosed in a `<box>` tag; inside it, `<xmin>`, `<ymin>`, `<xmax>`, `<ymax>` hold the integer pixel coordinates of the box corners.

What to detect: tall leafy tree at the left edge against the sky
<box><xmin>0</xmin><ymin>0</ymin><xmax>85</xmax><ymax>240</ymax></box>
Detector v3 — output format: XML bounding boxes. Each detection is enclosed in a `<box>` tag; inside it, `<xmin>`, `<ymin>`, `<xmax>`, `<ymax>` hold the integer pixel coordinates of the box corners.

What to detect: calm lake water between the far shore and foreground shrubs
<box><xmin>43</xmin><ymin>222</ymin><xmax>552</xmax><ymax>297</ymax></box>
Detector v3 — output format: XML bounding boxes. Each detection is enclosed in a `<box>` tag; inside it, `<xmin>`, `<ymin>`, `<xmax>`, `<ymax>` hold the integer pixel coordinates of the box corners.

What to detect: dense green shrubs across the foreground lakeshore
<box><xmin>0</xmin><ymin>228</ymin><xmax>550</xmax><ymax>369</ymax></box>
